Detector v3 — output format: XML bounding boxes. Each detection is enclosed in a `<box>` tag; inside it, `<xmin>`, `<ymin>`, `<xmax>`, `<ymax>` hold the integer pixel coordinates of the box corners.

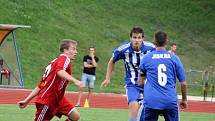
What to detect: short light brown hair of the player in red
<box><xmin>59</xmin><ymin>39</ymin><xmax>77</xmax><ymax>53</ymax></box>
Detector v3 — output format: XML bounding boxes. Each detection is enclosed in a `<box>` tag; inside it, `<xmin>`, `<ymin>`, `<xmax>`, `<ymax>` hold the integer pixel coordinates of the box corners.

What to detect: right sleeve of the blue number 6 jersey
<box><xmin>176</xmin><ymin>56</ymin><xmax>186</xmax><ymax>82</ymax></box>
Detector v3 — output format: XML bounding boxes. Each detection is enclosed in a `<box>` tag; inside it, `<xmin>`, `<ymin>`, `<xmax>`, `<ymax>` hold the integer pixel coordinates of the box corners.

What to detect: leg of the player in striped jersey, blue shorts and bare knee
<box><xmin>126</xmin><ymin>86</ymin><xmax>140</xmax><ymax>121</ymax></box>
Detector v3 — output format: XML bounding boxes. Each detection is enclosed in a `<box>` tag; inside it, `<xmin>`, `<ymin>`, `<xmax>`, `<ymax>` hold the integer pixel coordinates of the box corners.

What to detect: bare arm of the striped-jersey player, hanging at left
<box><xmin>100</xmin><ymin>57</ymin><xmax>115</xmax><ymax>88</ymax></box>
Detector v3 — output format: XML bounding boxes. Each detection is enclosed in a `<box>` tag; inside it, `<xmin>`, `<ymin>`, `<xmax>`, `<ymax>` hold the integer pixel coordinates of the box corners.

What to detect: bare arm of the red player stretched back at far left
<box><xmin>17</xmin><ymin>87</ymin><xmax>40</xmax><ymax>108</ymax></box>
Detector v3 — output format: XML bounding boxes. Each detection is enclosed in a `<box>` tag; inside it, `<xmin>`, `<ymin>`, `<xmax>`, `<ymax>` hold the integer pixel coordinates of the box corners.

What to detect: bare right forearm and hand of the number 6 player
<box><xmin>180</xmin><ymin>81</ymin><xmax>187</xmax><ymax>109</ymax></box>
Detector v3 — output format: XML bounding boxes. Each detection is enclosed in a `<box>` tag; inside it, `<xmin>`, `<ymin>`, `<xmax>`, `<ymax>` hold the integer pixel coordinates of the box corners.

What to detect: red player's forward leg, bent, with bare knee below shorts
<box><xmin>56</xmin><ymin>97</ymin><xmax>80</xmax><ymax>121</ymax></box>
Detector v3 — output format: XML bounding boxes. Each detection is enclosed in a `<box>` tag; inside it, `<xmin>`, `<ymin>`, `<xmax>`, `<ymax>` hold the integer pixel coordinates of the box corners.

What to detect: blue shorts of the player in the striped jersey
<box><xmin>125</xmin><ymin>85</ymin><xmax>143</xmax><ymax>103</ymax></box>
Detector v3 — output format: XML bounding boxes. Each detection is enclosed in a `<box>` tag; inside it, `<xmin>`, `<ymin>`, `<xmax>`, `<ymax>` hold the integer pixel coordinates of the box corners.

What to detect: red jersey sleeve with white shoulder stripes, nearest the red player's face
<box><xmin>56</xmin><ymin>56</ymin><xmax>70</xmax><ymax>72</ymax></box>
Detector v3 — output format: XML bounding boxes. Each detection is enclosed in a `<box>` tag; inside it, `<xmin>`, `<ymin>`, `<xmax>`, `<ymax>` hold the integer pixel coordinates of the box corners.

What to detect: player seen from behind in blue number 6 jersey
<box><xmin>139</xmin><ymin>31</ymin><xmax>187</xmax><ymax>121</ymax></box>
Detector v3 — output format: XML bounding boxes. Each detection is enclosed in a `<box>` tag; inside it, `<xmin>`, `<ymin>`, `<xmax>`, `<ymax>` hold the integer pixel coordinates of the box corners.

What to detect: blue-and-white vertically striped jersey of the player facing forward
<box><xmin>112</xmin><ymin>42</ymin><xmax>155</xmax><ymax>85</ymax></box>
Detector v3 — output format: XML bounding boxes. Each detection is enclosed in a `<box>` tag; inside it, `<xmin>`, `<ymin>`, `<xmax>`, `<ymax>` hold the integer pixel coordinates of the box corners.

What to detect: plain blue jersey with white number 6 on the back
<box><xmin>139</xmin><ymin>50</ymin><xmax>185</xmax><ymax>109</ymax></box>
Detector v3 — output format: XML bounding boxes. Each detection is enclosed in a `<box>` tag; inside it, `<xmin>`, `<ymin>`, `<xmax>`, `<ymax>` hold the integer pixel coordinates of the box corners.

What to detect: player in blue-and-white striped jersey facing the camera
<box><xmin>101</xmin><ymin>27</ymin><xmax>155</xmax><ymax>121</ymax></box>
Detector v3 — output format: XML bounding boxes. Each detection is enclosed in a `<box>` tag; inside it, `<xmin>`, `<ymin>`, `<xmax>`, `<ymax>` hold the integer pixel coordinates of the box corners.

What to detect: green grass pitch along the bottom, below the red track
<box><xmin>0</xmin><ymin>104</ymin><xmax>215</xmax><ymax>121</ymax></box>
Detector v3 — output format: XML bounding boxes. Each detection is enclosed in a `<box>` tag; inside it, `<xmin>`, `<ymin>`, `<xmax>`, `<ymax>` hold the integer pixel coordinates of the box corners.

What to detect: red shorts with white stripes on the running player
<box><xmin>34</xmin><ymin>97</ymin><xmax>74</xmax><ymax>121</ymax></box>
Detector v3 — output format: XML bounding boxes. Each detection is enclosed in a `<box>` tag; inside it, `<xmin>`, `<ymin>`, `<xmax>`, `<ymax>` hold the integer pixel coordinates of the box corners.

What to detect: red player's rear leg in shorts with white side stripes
<box><xmin>34</xmin><ymin>103</ymin><xmax>54</xmax><ymax>121</ymax></box>
